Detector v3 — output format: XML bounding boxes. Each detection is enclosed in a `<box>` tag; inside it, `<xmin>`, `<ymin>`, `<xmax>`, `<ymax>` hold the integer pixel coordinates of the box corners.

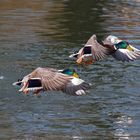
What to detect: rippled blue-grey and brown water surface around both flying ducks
<box><xmin>0</xmin><ymin>0</ymin><xmax>140</xmax><ymax>140</ymax></box>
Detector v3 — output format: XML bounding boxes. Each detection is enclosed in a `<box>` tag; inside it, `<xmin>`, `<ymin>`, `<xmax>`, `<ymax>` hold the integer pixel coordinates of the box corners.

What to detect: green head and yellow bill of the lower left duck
<box><xmin>62</xmin><ymin>68</ymin><xmax>79</xmax><ymax>78</ymax></box>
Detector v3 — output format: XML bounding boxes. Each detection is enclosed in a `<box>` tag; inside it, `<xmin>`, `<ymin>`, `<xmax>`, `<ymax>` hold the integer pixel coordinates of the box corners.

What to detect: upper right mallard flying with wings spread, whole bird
<box><xmin>69</xmin><ymin>34</ymin><xmax>140</xmax><ymax>64</ymax></box>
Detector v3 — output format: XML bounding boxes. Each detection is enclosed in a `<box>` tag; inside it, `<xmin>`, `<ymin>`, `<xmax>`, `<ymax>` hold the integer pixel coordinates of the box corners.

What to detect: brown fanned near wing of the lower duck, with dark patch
<box><xmin>14</xmin><ymin>67</ymin><xmax>72</xmax><ymax>92</ymax></box>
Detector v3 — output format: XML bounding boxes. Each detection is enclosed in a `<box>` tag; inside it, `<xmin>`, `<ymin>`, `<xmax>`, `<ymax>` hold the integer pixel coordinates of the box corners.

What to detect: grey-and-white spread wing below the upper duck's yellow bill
<box><xmin>112</xmin><ymin>46</ymin><xmax>140</xmax><ymax>62</ymax></box>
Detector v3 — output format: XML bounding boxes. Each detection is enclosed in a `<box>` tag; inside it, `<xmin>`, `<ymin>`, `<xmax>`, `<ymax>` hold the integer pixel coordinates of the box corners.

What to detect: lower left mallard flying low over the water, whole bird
<box><xmin>13</xmin><ymin>67</ymin><xmax>90</xmax><ymax>95</ymax></box>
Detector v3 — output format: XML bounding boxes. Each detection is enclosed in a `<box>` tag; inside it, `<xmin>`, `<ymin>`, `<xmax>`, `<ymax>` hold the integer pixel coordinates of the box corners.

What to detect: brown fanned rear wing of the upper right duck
<box><xmin>84</xmin><ymin>35</ymin><xmax>108</xmax><ymax>61</ymax></box>
